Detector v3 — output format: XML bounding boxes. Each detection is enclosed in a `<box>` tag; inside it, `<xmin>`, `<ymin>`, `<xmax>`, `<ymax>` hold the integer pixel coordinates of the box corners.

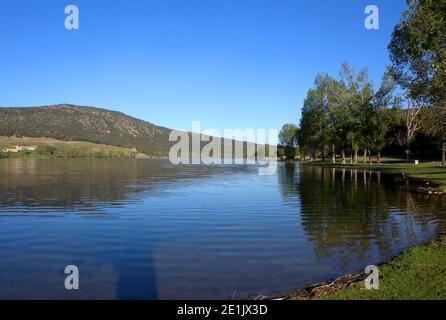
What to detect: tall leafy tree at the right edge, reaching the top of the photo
<box><xmin>389</xmin><ymin>0</ymin><xmax>446</xmax><ymax>166</ymax></box>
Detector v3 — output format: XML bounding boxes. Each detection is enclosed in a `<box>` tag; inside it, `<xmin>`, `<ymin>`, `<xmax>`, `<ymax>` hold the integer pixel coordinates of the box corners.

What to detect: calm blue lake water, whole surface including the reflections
<box><xmin>0</xmin><ymin>159</ymin><xmax>445</xmax><ymax>299</ymax></box>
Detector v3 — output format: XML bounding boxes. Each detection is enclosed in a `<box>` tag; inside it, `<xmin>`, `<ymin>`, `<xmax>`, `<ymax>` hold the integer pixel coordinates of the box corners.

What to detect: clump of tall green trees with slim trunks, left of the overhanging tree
<box><xmin>299</xmin><ymin>63</ymin><xmax>396</xmax><ymax>164</ymax></box>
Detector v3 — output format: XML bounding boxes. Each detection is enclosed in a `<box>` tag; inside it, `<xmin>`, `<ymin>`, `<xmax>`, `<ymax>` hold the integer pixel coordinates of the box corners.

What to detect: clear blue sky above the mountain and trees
<box><xmin>0</xmin><ymin>0</ymin><xmax>405</xmax><ymax>130</ymax></box>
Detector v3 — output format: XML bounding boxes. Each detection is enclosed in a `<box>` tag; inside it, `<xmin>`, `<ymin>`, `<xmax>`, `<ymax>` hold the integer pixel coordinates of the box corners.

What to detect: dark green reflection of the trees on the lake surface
<box><xmin>278</xmin><ymin>162</ymin><xmax>446</xmax><ymax>270</ymax></box>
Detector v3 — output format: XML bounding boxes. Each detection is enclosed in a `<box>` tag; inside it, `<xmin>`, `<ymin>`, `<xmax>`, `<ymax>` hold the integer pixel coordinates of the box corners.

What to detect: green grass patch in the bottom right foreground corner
<box><xmin>327</xmin><ymin>238</ymin><xmax>446</xmax><ymax>300</ymax></box>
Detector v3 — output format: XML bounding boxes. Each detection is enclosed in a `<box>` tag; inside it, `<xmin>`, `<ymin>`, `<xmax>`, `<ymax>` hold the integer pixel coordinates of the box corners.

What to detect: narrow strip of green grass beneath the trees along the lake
<box><xmin>307</xmin><ymin>159</ymin><xmax>446</xmax><ymax>190</ymax></box>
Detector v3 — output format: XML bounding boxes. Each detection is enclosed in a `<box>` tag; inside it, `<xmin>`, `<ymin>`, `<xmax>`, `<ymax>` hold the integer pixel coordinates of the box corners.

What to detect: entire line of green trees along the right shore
<box><xmin>279</xmin><ymin>0</ymin><xmax>446</xmax><ymax>167</ymax></box>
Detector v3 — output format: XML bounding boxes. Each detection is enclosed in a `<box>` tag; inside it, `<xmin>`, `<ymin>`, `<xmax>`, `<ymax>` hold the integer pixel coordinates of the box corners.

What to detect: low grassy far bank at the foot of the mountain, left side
<box><xmin>0</xmin><ymin>137</ymin><xmax>144</xmax><ymax>159</ymax></box>
